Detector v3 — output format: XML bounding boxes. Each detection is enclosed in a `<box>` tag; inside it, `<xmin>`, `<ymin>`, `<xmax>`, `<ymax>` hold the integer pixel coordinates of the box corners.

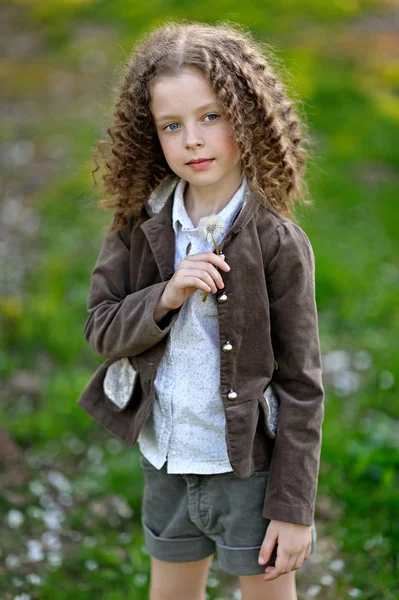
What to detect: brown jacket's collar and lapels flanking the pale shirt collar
<box><xmin>140</xmin><ymin>173</ymin><xmax>261</xmax><ymax>281</ymax></box>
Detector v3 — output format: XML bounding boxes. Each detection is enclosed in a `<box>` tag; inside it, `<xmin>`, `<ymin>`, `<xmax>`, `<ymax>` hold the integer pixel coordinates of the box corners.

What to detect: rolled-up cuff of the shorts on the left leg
<box><xmin>142</xmin><ymin>520</ymin><xmax>216</xmax><ymax>562</ymax></box>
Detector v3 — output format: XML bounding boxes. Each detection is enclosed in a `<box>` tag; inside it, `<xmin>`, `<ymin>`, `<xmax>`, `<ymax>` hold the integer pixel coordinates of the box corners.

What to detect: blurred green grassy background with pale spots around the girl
<box><xmin>0</xmin><ymin>0</ymin><xmax>399</xmax><ymax>600</ymax></box>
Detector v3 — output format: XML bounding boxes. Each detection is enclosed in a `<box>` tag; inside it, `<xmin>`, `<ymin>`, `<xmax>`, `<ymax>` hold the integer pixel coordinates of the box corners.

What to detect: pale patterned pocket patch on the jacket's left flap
<box><xmin>103</xmin><ymin>356</ymin><xmax>139</xmax><ymax>412</ymax></box>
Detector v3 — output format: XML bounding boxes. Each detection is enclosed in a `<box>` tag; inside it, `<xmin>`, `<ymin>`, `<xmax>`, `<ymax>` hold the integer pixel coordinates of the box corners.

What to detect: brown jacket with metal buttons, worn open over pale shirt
<box><xmin>77</xmin><ymin>176</ymin><xmax>324</xmax><ymax>525</ymax></box>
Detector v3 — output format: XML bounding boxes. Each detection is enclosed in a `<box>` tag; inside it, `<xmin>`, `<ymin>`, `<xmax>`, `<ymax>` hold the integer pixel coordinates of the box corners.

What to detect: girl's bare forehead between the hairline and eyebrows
<box><xmin>150</xmin><ymin>67</ymin><xmax>217</xmax><ymax>117</ymax></box>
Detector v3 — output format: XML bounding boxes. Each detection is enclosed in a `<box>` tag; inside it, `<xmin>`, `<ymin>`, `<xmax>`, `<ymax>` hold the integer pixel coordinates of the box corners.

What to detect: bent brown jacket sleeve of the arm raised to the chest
<box><xmin>84</xmin><ymin>223</ymin><xmax>180</xmax><ymax>358</ymax></box>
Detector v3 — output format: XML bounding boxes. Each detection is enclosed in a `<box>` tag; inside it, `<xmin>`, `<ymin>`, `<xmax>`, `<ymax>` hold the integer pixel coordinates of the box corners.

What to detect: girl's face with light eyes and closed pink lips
<box><xmin>150</xmin><ymin>67</ymin><xmax>241</xmax><ymax>186</ymax></box>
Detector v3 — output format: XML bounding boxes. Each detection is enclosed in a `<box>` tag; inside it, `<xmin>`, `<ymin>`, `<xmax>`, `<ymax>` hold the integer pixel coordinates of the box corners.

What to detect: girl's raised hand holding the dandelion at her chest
<box><xmin>161</xmin><ymin>252</ymin><xmax>230</xmax><ymax>310</ymax></box>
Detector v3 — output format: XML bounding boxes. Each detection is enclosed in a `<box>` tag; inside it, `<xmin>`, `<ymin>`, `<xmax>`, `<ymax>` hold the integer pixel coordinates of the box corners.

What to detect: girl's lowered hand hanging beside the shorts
<box><xmin>259</xmin><ymin>521</ymin><xmax>312</xmax><ymax>581</ymax></box>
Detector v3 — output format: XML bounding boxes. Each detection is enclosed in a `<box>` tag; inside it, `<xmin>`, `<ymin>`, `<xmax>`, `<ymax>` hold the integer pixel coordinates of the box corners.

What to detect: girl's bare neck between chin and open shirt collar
<box><xmin>184</xmin><ymin>174</ymin><xmax>242</xmax><ymax>227</ymax></box>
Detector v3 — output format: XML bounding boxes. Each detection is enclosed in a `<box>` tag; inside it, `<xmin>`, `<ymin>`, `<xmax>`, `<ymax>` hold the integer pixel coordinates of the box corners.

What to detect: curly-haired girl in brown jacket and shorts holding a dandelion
<box><xmin>78</xmin><ymin>22</ymin><xmax>324</xmax><ymax>600</ymax></box>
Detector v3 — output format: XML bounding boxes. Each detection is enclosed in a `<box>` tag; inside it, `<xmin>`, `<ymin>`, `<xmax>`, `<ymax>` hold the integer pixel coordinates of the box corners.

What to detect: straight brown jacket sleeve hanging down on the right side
<box><xmin>263</xmin><ymin>221</ymin><xmax>324</xmax><ymax>525</ymax></box>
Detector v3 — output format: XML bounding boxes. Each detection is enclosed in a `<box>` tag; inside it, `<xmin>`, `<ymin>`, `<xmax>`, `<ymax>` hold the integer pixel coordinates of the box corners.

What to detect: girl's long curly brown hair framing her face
<box><xmin>92</xmin><ymin>20</ymin><xmax>313</xmax><ymax>232</ymax></box>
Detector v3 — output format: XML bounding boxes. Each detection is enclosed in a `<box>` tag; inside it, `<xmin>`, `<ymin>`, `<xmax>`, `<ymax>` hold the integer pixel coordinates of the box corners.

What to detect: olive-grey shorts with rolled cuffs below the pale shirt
<box><xmin>140</xmin><ymin>453</ymin><xmax>317</xmax><ymax>576</ymax></box>
